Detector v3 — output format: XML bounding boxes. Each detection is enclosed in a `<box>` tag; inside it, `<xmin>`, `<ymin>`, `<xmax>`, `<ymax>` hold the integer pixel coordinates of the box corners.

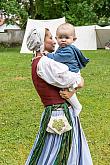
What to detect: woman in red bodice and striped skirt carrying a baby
<box><xmin>26</xmin><ymin>26</ymin><xmax>92</xmax><ymax>165</ymax></box>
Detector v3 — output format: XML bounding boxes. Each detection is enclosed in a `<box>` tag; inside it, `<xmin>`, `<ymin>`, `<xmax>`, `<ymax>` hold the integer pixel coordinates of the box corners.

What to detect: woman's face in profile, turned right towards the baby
<box><xmin>44</xmin><ymin>31</ymin><xmax>56</xmax><ymax>52</ymax></box>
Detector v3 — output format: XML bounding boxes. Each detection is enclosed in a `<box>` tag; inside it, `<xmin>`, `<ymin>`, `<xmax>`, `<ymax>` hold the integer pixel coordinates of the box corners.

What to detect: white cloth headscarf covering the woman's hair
<box><xmin>26</xmin><ymin>27</ymin><xmax>45</xmax><ymax>52</ymax></box>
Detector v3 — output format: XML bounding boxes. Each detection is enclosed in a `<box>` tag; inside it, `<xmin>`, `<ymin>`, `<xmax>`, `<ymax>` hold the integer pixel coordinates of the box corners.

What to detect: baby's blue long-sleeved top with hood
<box><xmin>47</xmin><ymin>45</ymin><xmax>89</xmax><ymax>73</ymax></box>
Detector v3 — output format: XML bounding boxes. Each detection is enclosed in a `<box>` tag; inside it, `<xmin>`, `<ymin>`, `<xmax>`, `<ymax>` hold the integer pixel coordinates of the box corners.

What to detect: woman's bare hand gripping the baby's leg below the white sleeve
<box><xmin>59</xmin><ymin>89</ymin><xmax>76</xmax><ymax>99</ymax></box>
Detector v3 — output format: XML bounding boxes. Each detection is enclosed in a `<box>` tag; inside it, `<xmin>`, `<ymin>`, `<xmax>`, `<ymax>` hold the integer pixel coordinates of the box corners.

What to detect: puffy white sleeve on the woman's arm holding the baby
<box><xmin>37</xmin><ymin>56</ymin><xmax>80</xmax><ymax>88</ymax></box>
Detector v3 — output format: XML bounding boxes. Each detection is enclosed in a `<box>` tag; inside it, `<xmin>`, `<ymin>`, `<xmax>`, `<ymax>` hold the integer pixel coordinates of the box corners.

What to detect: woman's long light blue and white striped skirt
<box><xmin>25</xmin><ymin>105</ymin><xmax>93</xmax><ymax>165</ymax></box>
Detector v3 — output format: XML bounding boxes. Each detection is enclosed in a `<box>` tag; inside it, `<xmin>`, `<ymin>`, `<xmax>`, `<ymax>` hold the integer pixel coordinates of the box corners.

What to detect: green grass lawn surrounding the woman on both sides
<box><xmin>0</xmin><ymin>48</ymin><xmax>110</xmax><ymax>165</ymax></box>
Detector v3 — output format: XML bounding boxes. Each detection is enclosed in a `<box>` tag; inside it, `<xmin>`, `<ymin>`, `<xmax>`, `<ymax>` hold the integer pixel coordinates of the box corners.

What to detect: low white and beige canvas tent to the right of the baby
<box><xmin>74</xmin><ymin>25</ymin><xmax>110</xmax><ymax>50</ymax></box>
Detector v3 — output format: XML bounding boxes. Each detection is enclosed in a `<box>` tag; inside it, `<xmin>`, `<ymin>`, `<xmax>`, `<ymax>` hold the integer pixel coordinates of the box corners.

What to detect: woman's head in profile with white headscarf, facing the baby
<box><xmin>27</xmin><ymin>28</ymin><xmax>56</xmax><ymax>52</ymax></box>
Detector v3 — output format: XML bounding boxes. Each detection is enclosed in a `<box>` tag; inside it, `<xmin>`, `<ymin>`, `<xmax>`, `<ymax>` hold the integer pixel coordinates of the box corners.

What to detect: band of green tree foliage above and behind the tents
<box><xmin>0</xmin><ymin>0</ymin><xmax>110</xmax><ymax>28</ymax></box>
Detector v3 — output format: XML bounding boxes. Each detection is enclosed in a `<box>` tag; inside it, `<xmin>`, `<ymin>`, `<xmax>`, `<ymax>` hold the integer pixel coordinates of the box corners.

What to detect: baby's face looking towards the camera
<box><xmin>56</xmin><ymin>31</ymin><xmax>76</xmax><ymax>47</ymax></box>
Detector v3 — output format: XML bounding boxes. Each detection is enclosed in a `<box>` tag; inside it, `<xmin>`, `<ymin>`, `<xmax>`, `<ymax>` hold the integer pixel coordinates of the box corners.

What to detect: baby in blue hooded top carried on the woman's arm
<box><xmin>46</xmin><ymin>23</ymin><xmax>89</xmax><ymax>116</ymax></box>
